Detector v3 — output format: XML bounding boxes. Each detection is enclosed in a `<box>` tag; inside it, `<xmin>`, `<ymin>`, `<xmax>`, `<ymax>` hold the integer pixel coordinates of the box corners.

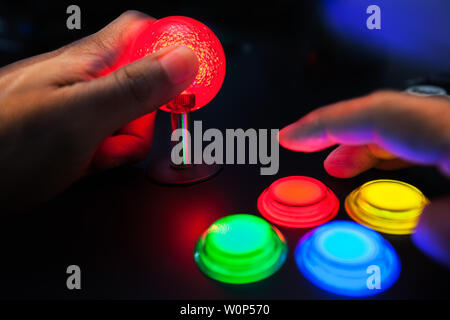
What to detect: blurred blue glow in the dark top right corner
<box><xmin>320</xmin><ymin>0</ymin><xmax>450</xmax><ymax>70</ymax></box>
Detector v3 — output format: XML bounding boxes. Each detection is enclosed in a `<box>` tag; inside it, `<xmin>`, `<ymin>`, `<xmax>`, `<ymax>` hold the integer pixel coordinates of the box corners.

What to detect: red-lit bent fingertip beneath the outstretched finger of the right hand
<box><xmin>324</xmin><ymin>145</ymin><xmax>380</xmax><ymax>178</ymax></box>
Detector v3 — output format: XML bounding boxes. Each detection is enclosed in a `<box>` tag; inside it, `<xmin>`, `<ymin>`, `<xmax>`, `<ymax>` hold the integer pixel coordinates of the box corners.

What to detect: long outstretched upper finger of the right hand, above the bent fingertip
<box><xmin>280</xmin><ymin>92</ymin><xmax>450</xmax><ymax>166</ymax></box>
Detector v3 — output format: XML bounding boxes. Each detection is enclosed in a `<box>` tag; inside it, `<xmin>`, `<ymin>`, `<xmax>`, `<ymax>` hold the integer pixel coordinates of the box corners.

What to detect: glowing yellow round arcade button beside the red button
<box><xmin>345</xmin><ymin>180</ymin><xmax>428</xmax><ymax>234</ymax></box>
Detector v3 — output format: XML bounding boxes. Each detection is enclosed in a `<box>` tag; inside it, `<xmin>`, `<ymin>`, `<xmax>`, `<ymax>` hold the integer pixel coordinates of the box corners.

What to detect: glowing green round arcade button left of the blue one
<box><xmin>194</xmin><ymin>214</ymin><xmax>287</xmax><ymax>284</ymax></box>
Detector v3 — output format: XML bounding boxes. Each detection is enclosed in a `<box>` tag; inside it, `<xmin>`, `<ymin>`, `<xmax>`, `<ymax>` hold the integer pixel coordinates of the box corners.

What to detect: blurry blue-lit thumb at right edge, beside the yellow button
<box><xmin>412</xmin><ymin>197</ymin><xmax>450</xmax><ymax>268</ymax></box>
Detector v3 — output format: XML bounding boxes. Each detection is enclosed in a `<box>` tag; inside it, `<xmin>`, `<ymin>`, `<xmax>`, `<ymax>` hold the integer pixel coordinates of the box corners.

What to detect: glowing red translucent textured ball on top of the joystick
<box><xmin>131</xmin><ymin>16</ymin><xmax>225</xmax><ymax>113</ymax></box>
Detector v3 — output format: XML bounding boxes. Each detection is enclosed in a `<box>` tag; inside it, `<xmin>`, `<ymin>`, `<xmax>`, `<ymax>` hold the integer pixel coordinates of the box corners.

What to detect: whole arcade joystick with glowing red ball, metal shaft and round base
<box><xmin>131</xmin><ymin>16</ymin><xmax>225</xmax><ymax>185</ymax></box>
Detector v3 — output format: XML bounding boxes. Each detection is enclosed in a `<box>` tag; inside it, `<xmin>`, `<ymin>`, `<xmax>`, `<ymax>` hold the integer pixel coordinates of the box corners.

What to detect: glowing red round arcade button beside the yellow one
<box><xmin>258</xmin><ymin>176</ymin><xmax>339</xmax><ymax>228</ymax></box>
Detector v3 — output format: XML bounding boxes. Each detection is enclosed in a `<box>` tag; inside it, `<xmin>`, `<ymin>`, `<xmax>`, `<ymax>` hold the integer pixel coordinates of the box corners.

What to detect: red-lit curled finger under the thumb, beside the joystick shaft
<box><xmin>90</xmin><ymin>111</ymin><xmax>156</xmax><ymax>171</ymax></box>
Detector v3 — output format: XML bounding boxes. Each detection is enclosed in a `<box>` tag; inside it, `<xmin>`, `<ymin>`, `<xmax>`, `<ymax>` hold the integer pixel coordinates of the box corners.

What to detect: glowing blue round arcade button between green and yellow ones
<box><xmin>295</xmin><ymin>221</ymin><xmax>400</xmax><ymax>297</ymax></box>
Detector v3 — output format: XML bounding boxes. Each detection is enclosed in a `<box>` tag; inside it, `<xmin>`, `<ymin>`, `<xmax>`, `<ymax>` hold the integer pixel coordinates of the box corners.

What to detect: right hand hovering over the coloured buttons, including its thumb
<box><xmin>279</xmin><ymin>91</ymin><xmax>450</xmax><ymax>266</ymax></box>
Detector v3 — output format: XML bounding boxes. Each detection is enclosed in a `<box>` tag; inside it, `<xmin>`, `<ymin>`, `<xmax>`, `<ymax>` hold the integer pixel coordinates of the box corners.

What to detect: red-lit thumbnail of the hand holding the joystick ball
<box><xmin>159</xmin><ymin>47</ymin><xmax>198</xmax><ymax>84</ymax></box>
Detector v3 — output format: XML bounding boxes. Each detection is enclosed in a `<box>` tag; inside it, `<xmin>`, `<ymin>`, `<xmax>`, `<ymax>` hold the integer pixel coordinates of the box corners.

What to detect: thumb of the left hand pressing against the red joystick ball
<box><xmin>67</xmin><ymin>47</ymin><xmax>198</xmax><ymax>137</ymax></box>
